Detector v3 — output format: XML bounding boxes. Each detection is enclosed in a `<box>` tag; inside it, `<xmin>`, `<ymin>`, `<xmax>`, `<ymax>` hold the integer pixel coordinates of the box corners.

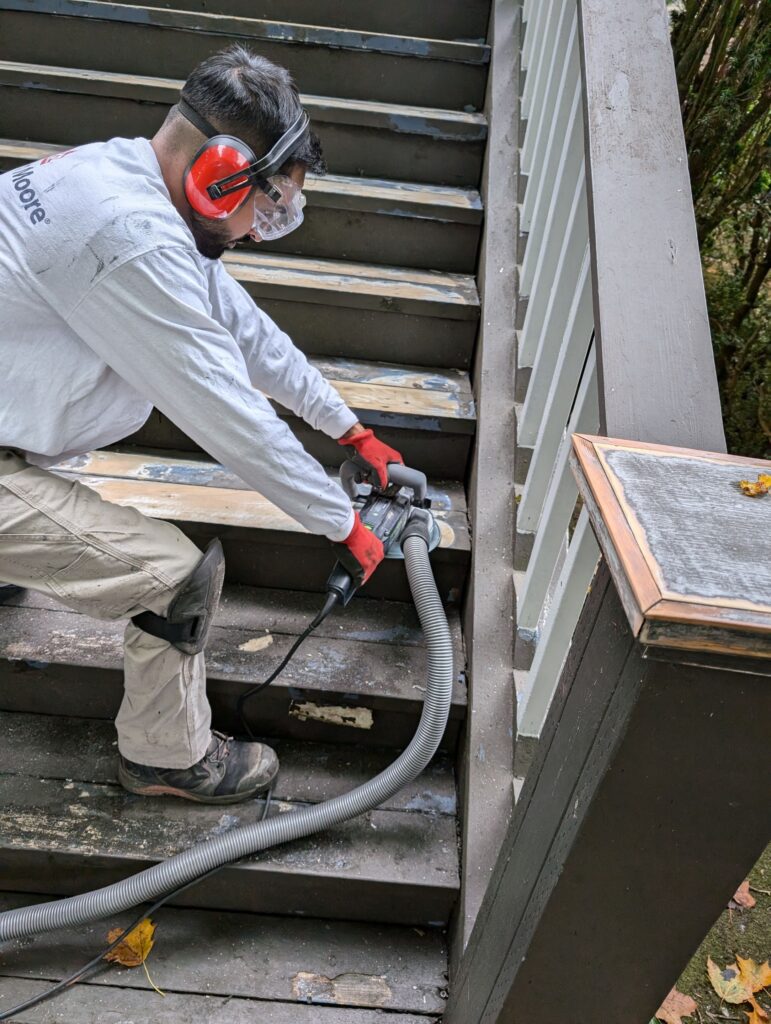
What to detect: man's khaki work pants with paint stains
<box><xmin>0</xmin><ymin>449</ymin><xmax>211</xmax><ymax>768</ymax></box>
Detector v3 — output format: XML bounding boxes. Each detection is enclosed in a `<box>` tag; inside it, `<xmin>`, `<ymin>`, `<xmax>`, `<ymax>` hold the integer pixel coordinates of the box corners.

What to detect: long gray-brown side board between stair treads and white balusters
<box><xmin>451</xmin><ymin>0</ymin><xmax>520</xmax><ymax>965</ymax></box>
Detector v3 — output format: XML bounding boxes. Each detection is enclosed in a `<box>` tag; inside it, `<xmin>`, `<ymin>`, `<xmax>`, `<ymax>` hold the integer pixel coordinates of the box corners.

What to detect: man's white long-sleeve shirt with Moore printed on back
<box><xmin>0</xmin><ymin>138</ymin><xmax>356</xmax><ymax>541</ymax></box>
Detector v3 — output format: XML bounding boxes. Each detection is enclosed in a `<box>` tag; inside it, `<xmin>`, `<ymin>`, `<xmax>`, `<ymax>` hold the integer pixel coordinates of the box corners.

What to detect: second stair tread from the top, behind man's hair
<box><xmin>0</xmin><ymin>60</ymin><xmax>487</xmax><ymax>141</ymax></box>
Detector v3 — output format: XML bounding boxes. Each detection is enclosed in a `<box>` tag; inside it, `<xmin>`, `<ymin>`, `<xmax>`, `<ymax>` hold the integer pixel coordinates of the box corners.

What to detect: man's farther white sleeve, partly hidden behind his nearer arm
<box><xmin>207</xmin><ymin>260</ymin><xmax>356</xmax><ymax>438</ymax></box>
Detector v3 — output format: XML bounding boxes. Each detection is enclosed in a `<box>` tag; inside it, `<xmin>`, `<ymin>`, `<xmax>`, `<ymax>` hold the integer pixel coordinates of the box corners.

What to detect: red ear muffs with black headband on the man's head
<box><xmin>177</xmin><ymin>97</ymin><xmax>309</xmax><ymax>220</ymax></box>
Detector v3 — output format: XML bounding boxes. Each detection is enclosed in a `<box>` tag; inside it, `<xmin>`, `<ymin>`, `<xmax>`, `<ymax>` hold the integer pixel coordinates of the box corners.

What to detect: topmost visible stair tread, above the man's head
<box><xmin>3</xmin><ymin>0</ymin><xmax>489</xmax><ymax>65</ymax></box>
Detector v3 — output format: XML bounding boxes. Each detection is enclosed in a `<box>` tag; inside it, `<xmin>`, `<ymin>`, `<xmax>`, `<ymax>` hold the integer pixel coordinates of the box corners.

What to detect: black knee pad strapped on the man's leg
<box><xmin>131</xmin><ymin>538</ymin><xmax>225</xmax><ymax>654</ymax></box>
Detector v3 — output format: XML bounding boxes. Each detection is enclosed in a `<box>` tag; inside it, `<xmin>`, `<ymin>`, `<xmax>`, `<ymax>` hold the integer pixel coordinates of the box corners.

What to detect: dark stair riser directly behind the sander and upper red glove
<box><xmin>122</xmin><ymin>410</ymin><xmax>473</xmax><ymax>480</ymax></box>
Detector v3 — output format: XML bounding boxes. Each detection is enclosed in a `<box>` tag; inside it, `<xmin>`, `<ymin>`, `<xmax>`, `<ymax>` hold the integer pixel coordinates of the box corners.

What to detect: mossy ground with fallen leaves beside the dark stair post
<box><xmin>663</xmin><ymin>844</ymin><xmax>771</xmax><ymax>1024</ymax></box>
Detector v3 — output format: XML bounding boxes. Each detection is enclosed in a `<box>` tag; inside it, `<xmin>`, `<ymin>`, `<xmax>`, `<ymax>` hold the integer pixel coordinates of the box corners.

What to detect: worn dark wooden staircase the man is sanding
<box><xmin>0</xmin><ymin>0</ymin><xmax>489</xmax><ymax>1024</ymax></box>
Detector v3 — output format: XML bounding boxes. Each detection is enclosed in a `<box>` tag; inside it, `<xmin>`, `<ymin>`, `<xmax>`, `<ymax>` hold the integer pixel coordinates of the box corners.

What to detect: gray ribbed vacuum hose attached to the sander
<box><xmin>0</xmin><ymin>536</ymin><xmax>454</xmax><ymax>942</ymax></box>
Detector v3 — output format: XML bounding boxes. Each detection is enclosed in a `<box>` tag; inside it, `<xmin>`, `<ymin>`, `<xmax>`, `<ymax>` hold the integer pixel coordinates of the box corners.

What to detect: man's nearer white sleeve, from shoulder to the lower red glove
<box><xmin>68</xmin><ymin>248</ymin><xmax>353</xmax><ymax>541</ymax></box>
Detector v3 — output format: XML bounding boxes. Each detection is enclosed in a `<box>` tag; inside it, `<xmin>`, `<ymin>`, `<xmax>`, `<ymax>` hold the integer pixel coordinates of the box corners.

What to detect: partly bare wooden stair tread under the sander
<box><xmin>51</xmin><ymin>452</ymin><xmax>470</xmax><ymax>551</ymax></box>
